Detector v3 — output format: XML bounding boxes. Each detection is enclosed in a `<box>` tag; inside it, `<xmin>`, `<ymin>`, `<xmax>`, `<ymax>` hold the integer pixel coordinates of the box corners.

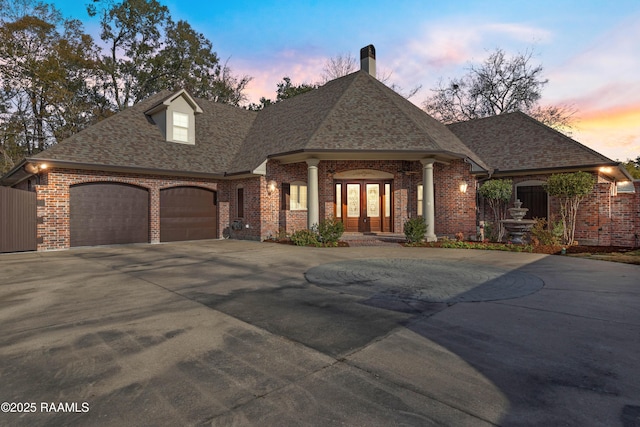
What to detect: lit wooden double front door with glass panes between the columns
<box><xmin>336</xmin><ymin>181</ymin><xmax>391</xmax><ymax>233</ymax></box>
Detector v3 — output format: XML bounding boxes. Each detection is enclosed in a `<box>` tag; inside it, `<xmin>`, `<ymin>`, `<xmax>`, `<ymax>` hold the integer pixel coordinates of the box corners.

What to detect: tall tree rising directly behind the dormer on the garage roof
<box><xmin>87</xmin><ymin>0</ymin><xmax>251</xmax><ymax>110</ymax></box>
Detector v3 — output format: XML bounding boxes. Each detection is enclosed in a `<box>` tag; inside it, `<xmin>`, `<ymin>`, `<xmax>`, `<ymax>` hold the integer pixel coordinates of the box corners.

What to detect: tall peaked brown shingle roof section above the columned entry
<box><xmin>232</xmin><ymin>71</ymin><xmax>488</xmax><ymax>170</ymax></box>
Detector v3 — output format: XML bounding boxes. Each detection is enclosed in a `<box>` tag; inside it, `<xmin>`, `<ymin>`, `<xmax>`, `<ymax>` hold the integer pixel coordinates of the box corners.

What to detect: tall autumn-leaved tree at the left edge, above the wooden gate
<box><xmin>0</xmin><ymin>0</ymin><xmax>103</xmax><ymax>170</ymax></box>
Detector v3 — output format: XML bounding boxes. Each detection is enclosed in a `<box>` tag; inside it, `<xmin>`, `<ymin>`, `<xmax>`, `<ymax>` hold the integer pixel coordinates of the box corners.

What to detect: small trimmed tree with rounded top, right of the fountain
<box><xmin>543</xmin><ymin>172</ymin><xmax>596</xmax><ymax>245</ymax></box>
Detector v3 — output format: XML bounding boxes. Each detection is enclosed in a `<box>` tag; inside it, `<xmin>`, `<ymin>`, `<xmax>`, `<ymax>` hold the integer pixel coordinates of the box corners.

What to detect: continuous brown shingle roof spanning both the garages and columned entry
<box><xmin>30</xmin><ymin>71</ymin><xmax>487</xmax><ymax>174</ymax></box>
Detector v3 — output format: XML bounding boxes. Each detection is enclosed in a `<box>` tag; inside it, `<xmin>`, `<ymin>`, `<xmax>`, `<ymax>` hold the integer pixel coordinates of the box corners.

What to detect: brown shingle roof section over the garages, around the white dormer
<box><xmin>35</xmin><ymin>91</ymin><xmax>257</xmax><ymax>174</ymax></box>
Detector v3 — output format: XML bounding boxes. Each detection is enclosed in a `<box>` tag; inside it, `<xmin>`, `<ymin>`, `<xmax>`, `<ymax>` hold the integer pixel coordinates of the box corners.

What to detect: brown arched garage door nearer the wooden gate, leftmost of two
<box><xmin>69</xmin><ymin>182</ymin><xmax>149</xmax><ymax>246</ymax></box>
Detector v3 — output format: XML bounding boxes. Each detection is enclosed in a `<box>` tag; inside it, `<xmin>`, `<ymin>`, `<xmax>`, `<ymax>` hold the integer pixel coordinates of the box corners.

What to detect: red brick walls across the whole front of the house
<box><xmin>28</xmin><ymin>160</ymin><xmax>640</xmax><ymax>250</ymax></box>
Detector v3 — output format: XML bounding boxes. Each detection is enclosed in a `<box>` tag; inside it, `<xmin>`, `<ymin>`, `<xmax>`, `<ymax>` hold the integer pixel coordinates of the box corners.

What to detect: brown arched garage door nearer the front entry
<box><xmin>160</xmin><ymin>187</ymin><xmax>218</xmax><ymax>242</ymax></box>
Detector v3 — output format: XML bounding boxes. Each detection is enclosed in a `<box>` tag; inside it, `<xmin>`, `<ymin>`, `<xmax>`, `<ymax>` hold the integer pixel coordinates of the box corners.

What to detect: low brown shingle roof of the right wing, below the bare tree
<box><xmin>447</xmin><ymin>112</ymin><xmax>617</xmax><ymax>171</ymax></box>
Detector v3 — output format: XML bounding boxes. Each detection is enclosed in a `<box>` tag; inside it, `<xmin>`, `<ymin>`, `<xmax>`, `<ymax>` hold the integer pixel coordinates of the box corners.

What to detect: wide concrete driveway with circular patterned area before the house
<box><xmin>0</xmin><ymin>240</ymin><xmax>640</xmax><ymax>427</ymax></box>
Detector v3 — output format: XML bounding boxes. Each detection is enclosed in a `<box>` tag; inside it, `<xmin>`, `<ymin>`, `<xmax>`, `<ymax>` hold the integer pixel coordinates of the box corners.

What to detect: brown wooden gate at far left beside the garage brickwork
<box><xmin>0</xmin><ymin>186</ymin><xmax>37</xmax><ymax>252</ymax></box>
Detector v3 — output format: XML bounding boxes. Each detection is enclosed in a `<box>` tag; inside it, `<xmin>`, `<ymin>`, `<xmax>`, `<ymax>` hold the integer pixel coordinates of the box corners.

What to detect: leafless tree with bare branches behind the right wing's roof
<box><xmin>423</xmin><ymin>49</ymin><xmax>575</xmax><ymax>131</ymax></box>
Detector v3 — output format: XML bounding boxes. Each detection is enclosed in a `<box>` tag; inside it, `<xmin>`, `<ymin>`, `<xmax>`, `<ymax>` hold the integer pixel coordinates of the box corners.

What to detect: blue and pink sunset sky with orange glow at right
<box><xmin>53</xmin><ymin>0</ymin><xmax>640</xmax><ymax>161</ymax></box>
